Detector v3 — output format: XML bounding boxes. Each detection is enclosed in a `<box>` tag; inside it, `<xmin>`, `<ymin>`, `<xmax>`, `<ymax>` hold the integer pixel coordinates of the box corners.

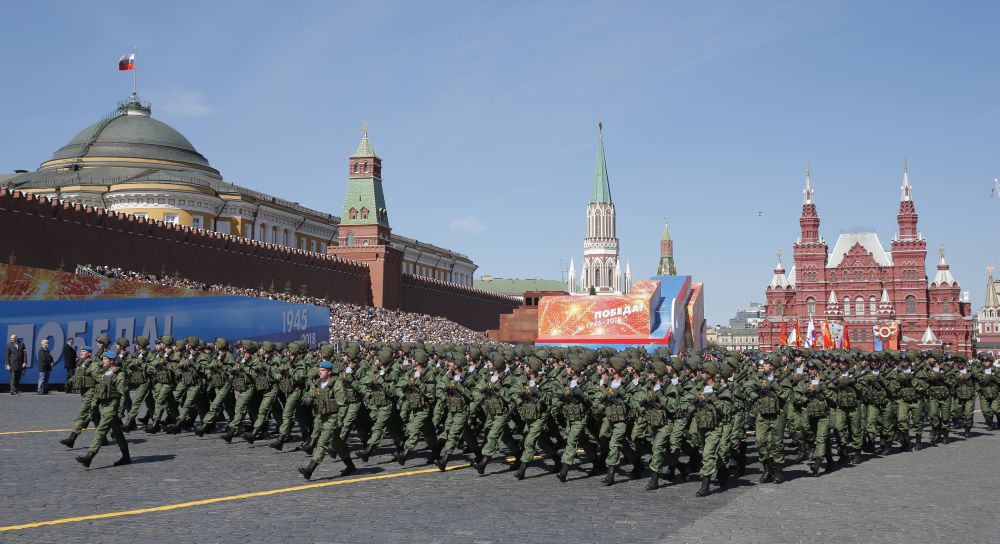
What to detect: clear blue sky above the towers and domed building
<box><xmin>0</xmin><ymin>1</ymin><xmax>1000</xmax><ymax>324</ymax></box>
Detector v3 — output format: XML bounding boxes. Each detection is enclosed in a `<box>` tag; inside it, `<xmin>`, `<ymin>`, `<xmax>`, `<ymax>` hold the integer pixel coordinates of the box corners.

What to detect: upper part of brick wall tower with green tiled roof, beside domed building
<box><xmin>338</xmin><ymin>127</ymin><xmax>392</xmax><ymax>247</ymax></box>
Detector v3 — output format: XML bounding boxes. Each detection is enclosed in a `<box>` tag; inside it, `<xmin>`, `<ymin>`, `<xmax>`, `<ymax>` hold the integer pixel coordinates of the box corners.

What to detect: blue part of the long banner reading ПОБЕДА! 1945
<box><xmin>0</xmin><ymin>297</ymin><xmax>330</xmax><ymax>384</ymax></box>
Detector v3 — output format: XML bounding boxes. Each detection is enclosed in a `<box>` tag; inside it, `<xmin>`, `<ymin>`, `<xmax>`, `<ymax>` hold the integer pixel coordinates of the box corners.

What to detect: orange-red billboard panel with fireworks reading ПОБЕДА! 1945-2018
<box><xmin>538</xmin><ymin>280</ymin><xmax>660</xmax><ymax>340</ymax></box>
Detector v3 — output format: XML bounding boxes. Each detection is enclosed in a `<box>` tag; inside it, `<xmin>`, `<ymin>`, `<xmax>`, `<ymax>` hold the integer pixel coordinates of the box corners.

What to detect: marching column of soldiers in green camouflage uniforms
<box><xmin>61</xmin><ymin>336</ymin><xmax>1000</xmax><ymax>496</ymax></box>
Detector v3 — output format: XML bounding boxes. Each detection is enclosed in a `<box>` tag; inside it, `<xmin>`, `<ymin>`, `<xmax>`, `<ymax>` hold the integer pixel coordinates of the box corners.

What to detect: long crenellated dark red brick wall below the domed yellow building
<box><xmin>0</xmin><ymin>189</ymin><xmax>371</xmax><ymax>305</ymax></box>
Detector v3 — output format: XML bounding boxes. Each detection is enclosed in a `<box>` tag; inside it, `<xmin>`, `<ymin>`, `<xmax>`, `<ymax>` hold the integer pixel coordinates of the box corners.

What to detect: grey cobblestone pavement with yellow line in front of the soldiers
<box><xmin>0</xmin><ymin>393</ymin><xmax>1000</xmax><ymax>544</ymax></box>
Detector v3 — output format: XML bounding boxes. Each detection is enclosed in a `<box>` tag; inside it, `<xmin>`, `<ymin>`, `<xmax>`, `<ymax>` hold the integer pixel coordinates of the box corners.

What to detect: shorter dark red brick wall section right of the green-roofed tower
<box><xmin>400</xmin><ymin>274</ymin><xmax>521</xmax><ymax>331</ymax></box>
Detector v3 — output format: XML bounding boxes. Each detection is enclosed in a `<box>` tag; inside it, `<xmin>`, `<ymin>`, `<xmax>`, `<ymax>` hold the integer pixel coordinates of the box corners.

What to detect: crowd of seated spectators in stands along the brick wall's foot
<box><xmin>76</xmin><ymin>265</ymin><xmax>489</xmax><ymax>344</ymax></box>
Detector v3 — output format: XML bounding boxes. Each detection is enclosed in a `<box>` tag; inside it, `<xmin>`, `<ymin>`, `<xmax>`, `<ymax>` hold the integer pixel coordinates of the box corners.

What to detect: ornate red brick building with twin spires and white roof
<box><xmin>758</xmin><ymin>165</ymin><xmax>973</xmax><ymax>354</ymax></box>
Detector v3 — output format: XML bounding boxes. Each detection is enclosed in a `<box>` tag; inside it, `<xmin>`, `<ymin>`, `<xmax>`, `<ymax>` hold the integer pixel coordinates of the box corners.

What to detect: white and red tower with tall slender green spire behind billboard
<box><xmin>579</xmin><ymin>123</ymin><xmax>628</xmax><ymax>294</ymax></box>
